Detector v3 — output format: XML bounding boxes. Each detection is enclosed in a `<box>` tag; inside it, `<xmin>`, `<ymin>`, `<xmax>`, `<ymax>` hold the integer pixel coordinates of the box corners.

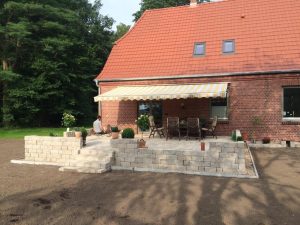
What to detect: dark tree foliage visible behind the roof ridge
<box><xmin>133</xmin><ymin>0</ymin><xmax>210</xmax><ymax>22</ymax></box>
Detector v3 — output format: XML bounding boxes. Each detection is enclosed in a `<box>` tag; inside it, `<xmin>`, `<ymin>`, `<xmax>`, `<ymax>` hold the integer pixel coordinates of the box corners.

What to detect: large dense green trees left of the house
<box><xmin>0</xmin><ymin>0</ymin><xmax>113</xmax><ymax>126</ymax></box>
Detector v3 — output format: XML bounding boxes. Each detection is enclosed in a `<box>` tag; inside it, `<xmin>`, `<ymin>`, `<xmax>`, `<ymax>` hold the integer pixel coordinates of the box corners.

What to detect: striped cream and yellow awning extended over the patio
<box><xmin>94</xmin><ymin>83</ymin><xmax>228</xmax><ymax>102</ymax></box>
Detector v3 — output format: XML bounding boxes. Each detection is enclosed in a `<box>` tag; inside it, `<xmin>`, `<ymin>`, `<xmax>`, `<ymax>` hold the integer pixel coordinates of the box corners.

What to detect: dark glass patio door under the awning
<box><xmin>138</xmin><ymin>101</ymin><xmax>163</xmax><ymax>125</ymax></box>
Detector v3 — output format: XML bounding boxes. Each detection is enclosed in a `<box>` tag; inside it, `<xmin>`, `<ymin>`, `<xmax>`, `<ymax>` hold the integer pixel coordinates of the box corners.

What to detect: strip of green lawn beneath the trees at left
<box><xmin>0</xmin><ymin>128</ymin><xmax>66</xmax><ymax>139</ymax></box>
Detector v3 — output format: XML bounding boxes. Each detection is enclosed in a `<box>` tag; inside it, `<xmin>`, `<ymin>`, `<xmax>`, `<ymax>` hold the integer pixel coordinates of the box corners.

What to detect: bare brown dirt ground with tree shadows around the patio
<box><xmin>0</xmin><ymin>140</ymin><xmax>300</xmax><ymax>225</ymax></box>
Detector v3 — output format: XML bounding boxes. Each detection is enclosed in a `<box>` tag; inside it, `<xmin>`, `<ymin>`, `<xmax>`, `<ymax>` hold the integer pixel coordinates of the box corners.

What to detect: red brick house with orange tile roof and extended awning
<box><xmin>95</xmin><ymin>0</ymin><xmax>300</xmax><ymax>141</ymax></box>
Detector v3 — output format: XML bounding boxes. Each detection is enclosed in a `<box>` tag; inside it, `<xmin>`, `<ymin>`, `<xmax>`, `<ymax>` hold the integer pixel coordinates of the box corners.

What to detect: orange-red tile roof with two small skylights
<box><xmin>97</xmin><ymin>0</ymin><xmax>300</xmax><ymax>80</ymax></box>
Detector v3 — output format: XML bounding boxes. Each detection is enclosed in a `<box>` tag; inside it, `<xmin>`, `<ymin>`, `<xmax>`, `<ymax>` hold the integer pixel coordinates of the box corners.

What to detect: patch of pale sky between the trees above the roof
<box><xmin>89</xmin><ymin>0</ymin><xmax>141</xmax><ymax>30</ymax></box>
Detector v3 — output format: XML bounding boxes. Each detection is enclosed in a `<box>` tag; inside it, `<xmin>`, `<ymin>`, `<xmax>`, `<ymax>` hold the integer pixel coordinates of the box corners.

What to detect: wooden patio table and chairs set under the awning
<box><xmin>149</xmin><ymin>116</ymin><xmax>218</xmax><ymax>140</ymax></box>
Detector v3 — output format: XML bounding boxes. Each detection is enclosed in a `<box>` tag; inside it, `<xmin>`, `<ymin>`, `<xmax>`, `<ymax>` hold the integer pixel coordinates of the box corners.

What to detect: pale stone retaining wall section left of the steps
<box><xmin>25</xmin><ymin>136</ymin><xmax>82</xmax><ymax>166</ymax></box>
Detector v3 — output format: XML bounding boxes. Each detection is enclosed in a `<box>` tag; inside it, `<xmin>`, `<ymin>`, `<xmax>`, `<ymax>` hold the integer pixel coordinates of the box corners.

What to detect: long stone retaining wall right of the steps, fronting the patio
<box><xmin>111</xmin><ymin>139</ymin><xmax>246</xmax><ymax>176</ymax></box>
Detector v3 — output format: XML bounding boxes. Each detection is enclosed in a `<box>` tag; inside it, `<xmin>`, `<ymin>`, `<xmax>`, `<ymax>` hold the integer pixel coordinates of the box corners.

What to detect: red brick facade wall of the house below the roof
<box><xmin>100</xmin><ymin>74</ymin><xmax>300</xmax><ymax>141</ymax></box>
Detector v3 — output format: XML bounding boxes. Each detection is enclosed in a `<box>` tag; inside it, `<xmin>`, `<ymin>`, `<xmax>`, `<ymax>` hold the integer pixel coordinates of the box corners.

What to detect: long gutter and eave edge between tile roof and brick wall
<box><xmin>97</xmin><ymin>69</ymin><xmax>300</xmax><ymax>83</ymax></box>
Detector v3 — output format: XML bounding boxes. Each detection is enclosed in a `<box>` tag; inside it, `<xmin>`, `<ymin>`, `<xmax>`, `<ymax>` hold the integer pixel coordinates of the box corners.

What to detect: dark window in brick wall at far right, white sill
<box><xmin>283</xmin><ymin>87</ymin><xmax>300</xmax><ymax>119</ymax></box>
